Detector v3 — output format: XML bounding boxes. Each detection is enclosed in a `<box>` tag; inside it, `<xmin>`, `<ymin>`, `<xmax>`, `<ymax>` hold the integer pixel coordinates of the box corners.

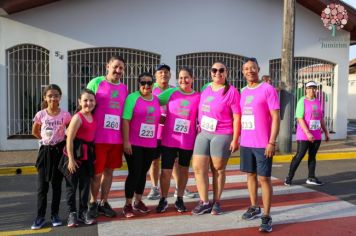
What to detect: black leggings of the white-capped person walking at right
<box><xmin>288</xmin><ymin>140</ymin><xmax>321</xmax><ymax>179</ymax></box>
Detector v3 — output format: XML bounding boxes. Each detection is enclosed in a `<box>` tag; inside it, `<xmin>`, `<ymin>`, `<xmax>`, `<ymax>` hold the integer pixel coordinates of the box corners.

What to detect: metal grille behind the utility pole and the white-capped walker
<box><xmin>269</xmin><ymin>57</ymin><xmax>335</xmax><ymax>132</ymax></box>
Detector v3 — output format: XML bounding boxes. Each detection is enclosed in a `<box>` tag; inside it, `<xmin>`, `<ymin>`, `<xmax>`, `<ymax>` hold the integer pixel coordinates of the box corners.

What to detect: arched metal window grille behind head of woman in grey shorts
<box><xmin>176</xmin><ymin>52</ymin><xmax>247</xmax><ymax>91</ymax></box>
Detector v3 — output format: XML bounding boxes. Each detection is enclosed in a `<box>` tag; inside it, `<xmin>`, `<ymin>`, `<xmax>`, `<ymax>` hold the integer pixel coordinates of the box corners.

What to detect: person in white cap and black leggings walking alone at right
<box><xmin>284</xmin><ymin>81</ymin><xmax>329</xmax><ymax>185</ymax></box>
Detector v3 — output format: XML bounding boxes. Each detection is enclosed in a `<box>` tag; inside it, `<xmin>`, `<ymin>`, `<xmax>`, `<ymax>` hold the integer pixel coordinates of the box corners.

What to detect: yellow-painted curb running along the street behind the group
<box><xmin>0</xmin><ymin>152</ymin><xmax>356</xmax><ymax>176</ymax></box>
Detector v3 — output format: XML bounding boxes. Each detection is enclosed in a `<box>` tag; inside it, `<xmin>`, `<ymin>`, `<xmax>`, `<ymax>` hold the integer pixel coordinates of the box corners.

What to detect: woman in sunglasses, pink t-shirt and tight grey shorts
<box><xmin>192</xmin><ymin>62</ymin><xmax>241</xmax><ymax>215</ymax></box>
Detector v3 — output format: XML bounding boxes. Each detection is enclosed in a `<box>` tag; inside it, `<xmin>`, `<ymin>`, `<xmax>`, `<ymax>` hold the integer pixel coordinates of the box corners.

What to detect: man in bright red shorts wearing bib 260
<box><xmin>87</xmin><ymin>56</ymin><xmax>128</xmax><ymax>218</ymax></box>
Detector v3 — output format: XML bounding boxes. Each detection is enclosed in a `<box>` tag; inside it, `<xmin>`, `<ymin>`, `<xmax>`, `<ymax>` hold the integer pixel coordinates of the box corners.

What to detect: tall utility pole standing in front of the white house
<box><xmin>278</xmin><ymin>0</ymin><xmax>295</xmax><ymax>153</ymax></box>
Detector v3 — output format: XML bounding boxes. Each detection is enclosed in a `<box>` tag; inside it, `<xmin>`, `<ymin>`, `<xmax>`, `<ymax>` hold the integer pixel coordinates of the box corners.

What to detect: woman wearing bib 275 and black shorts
<box><xmin>156</xmin><ymin>68</ymin><xmax>200</xmax><ymax>213</ymax></box>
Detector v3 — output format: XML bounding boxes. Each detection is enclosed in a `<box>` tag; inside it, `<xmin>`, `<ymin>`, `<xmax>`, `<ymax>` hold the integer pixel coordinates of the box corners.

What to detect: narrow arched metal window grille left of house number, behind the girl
<box><xmin>6</xmin><ymin>44</ymin><xmax>49</xmax><ymax>138</ymax></box>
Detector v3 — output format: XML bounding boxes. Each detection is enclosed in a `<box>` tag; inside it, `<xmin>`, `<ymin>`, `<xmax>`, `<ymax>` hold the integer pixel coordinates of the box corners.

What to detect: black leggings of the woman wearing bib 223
<box><xmin>125</xmin><ymin>146</ymin><xmax>157</xmax><ymax>199</ymax></box>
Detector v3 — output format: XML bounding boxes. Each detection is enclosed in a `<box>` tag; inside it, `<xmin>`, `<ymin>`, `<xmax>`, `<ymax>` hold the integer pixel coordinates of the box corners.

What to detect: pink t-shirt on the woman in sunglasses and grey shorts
<box><xmin>199</xmin><ymin>85</ymin><xmax>241</xmax><ymax>134</ymax></box>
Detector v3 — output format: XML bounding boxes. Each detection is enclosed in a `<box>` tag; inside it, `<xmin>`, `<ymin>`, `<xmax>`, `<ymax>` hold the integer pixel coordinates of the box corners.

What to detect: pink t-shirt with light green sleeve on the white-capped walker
<box><xmin>296</xmin><ymin>97</ymin><xmax>323</xmax><ymax>141</ymax></box>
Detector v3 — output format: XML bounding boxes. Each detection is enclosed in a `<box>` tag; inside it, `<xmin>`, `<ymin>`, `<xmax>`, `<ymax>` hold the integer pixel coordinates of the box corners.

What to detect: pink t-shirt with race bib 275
<box><xmin>159</xmin><ymin>88</ymin><xmax>200</xmax><ymax>150</ymax></box>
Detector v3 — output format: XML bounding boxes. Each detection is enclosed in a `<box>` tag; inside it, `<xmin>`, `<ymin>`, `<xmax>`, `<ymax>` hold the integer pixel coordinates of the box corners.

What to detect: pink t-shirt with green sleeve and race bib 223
<box><xmin>123</xmin><ymin>91</ymin><xmax>161</xmax><ymax>148</ymax></box>
